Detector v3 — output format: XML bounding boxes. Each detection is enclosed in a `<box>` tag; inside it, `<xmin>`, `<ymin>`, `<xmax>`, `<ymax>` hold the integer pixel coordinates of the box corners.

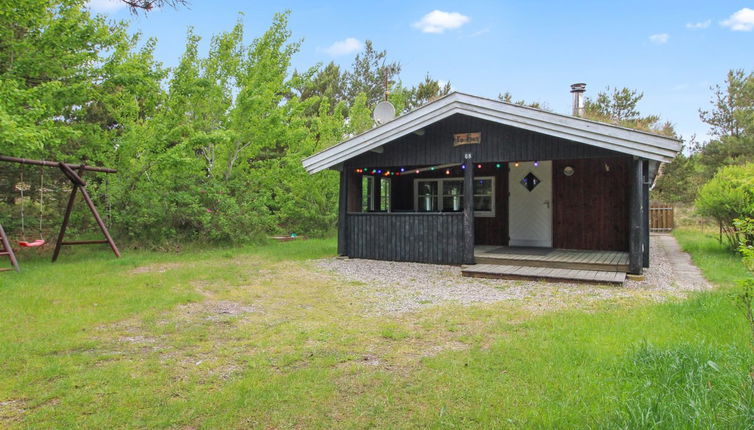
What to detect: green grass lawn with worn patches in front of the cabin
<box><xmin>0</xmin><ymin>230</ymin><xmax>754</xmax><ymax>429</ymax></box>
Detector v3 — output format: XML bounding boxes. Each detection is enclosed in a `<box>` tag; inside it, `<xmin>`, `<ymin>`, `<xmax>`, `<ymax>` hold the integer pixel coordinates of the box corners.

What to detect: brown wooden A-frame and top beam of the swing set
<box><xmin>0</xmin><ymin>155</ymin><xmax>120</xmax><ymax>270</ymax></box>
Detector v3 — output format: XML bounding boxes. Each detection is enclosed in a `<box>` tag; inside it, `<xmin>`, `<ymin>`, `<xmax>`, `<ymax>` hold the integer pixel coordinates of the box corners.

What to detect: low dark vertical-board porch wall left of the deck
<box><xmin>347</xmin><ymin>212</ymin><xmax>463</xmax><ymax>264</ymax></box>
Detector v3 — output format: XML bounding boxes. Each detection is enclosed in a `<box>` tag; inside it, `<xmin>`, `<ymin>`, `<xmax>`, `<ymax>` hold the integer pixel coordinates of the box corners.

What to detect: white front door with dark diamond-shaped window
<box><xmin>508</xmin><ymin>161</ymin><xmax>552</xmax><ymax>247</ymax></box>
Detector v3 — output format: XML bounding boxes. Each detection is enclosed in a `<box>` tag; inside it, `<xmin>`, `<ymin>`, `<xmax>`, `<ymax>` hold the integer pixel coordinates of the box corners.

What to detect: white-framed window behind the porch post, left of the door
<box><xmin>414</xmin><ymin>177</ymin><xmax>495</xmax><ymax>217</ymax></box>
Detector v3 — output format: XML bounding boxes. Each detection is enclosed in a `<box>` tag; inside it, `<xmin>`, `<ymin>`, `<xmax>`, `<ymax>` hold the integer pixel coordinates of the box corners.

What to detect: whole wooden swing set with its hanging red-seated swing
<box><xmin>0</xmin><ymin>155</ymin><xmax>120</xmax><ymax>272</ymax></box>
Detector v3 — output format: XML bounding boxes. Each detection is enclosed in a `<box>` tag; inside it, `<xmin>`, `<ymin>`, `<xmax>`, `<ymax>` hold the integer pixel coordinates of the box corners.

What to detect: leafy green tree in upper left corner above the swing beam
<box><xmin>0</xmin><ymin>0</ymin><xmax>128</xmax><ymax>157</ymax></box>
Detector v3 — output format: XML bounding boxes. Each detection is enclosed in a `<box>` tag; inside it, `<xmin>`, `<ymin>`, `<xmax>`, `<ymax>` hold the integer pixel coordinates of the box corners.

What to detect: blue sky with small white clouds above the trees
<box><xmin>90</xmin><ymin>0</ymin><xmax>754</xmax><ymax>144</ymax></box>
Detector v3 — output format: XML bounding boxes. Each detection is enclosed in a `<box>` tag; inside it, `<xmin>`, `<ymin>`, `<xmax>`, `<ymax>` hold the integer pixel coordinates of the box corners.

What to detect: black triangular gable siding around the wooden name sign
<box><xmin>346</xmin><ymin>115</ymin><xmax>618</xmax><ymax>168</ymax></box>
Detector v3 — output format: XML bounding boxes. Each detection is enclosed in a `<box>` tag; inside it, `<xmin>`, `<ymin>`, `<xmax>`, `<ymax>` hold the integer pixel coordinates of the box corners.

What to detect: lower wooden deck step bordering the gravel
<box><xmin>461</xmin><ymin>264</ymin><xmax>626</xmax><ymax>284</ymax></box>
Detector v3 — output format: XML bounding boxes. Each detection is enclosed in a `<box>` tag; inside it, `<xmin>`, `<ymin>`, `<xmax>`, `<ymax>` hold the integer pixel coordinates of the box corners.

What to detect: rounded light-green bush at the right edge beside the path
<box><xmin>696</xmin><ymin>163</ymin><xmax>754</xmax><ymax>249</ymax></box>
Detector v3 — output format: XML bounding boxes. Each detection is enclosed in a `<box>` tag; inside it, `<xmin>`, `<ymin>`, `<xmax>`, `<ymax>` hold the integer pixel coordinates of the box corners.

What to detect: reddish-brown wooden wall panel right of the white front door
<box><xmin>553</xmin><ymin>157</ymin><xmax>631</xmax><ymax>251</ymax></box>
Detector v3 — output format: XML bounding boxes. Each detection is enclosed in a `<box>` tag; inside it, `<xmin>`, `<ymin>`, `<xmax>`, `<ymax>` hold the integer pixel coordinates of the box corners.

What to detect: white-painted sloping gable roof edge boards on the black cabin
<box><xmin>303</xmin><ymin>92</ymin><xmax>681</xmax><ymax>173</ymax></box>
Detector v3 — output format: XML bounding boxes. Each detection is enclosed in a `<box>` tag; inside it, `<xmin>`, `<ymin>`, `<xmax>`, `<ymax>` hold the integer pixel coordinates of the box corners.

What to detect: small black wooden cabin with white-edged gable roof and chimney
<box><xmin>303</xmin><ymin>84</ymin><xmax>681</xmax><ymax>276</ymax></box>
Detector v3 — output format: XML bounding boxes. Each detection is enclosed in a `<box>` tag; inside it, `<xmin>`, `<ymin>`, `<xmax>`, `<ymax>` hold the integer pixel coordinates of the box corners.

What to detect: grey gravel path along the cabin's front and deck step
<box><xmin>315</xmin><ymin>236</ymin><xmax>710</xmax><ymax>314</ymax></box>
